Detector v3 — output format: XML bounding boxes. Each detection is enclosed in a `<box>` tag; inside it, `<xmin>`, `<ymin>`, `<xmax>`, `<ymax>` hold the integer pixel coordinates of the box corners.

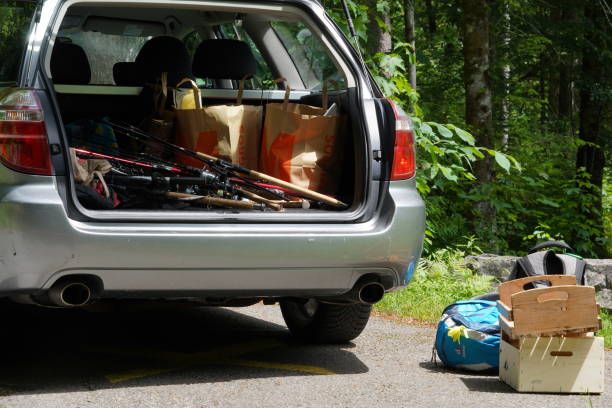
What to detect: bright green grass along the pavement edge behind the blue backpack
<box><xmin>375</xmin><ymin>249</ymin><xmax>612</xmax><ymax>348</ymax></box>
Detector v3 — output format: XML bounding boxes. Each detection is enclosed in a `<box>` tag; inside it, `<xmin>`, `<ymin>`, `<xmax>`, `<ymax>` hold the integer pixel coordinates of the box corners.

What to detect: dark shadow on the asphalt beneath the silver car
<box><xmin>0</xmin><ymin>303</ymin><xmax>368</xmax><ymax>395</ymax></box>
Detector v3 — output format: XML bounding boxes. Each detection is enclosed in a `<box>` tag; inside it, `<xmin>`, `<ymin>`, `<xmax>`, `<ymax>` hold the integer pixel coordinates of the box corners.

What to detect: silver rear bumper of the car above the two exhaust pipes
<box><xmin>0</xmin><ymin>176</ymin><xmax>425</xmax><ymax>297</ymax></box>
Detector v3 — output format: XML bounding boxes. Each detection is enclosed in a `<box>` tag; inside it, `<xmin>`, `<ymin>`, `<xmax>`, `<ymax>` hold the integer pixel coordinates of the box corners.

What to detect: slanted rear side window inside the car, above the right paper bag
<box><xmin>271</xmin><ymin>21</ymin><xmax>346</xmax><ymax>89</ymax></box>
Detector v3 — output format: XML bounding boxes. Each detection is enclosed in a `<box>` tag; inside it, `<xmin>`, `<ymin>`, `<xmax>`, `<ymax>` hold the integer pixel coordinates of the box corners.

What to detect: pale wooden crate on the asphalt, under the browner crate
<box><xmin>499</xmin><ymin>336</ymin><xmax>605</xmax><ymax>394</ymax></box>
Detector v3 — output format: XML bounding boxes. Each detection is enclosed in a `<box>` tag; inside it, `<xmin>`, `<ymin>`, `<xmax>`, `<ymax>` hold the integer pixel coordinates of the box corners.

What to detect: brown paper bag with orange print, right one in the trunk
<box><xmin>259</xmin><ymin>84</ymin><xmax>343</xmax><ymax>195</ymax></box>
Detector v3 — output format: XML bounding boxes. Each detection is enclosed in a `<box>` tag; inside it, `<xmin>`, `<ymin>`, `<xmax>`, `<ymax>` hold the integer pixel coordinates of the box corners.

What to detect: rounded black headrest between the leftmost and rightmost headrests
<box><xmin>136</xmin><ymin>36</ymin><xmax>193</xmax><ymax>86</ymax></box>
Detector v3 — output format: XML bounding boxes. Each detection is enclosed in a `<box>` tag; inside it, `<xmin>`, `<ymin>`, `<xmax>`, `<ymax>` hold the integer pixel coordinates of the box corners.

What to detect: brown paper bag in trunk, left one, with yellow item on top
<box><xmin>175</xmin><ymin>79</ymin><xmax>263</xmax><ymax>169</ymax></box>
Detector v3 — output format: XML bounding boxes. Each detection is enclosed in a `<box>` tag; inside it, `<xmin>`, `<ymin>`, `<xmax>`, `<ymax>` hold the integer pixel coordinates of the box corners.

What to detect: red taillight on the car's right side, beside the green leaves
<box><xmin>388</xmin><ymin>99</ymin><xmax>416</xmax><ymax>180</ymax></box>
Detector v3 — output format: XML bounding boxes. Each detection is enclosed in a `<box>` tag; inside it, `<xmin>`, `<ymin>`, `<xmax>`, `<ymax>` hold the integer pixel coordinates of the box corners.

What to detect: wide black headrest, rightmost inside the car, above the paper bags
<box><xmin>193</xmin><ymin>39</ymin><xmax>257</xmax><ymax>80</ymax></box>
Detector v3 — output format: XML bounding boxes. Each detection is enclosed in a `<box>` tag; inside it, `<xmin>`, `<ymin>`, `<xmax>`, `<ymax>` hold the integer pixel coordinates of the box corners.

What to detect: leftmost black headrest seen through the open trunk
<box><xmin>51</xmin><ymin>42</ymin><xmax>91</xmax><ymax>85</ymax></box>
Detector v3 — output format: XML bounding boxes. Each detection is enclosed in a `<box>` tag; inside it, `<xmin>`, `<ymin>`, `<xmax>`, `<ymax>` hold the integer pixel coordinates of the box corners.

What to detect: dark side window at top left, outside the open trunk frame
<box><xmin>0</xmin><ymin>1</ymin><xmax>37</xmax><ymax>86</ymax></box>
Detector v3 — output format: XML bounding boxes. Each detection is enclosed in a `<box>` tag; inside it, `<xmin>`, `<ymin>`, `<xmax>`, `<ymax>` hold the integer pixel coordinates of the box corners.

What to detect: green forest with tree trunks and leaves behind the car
<box><xmin>322</xmin><ymin>0</ymin><xmax>612</xmax><ymax>258</ymax></box>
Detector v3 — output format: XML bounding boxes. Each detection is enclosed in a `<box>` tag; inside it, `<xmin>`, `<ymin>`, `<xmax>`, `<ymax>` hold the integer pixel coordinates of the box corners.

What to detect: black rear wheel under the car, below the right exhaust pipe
<box><xmin>280</xmin><ymin>299</ymin><xmax>372</xmax><ymax>344</ymax></box>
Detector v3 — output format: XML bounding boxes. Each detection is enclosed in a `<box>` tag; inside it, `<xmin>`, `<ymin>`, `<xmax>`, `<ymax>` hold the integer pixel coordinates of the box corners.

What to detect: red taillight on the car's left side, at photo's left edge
<box><xmin>0</xmin><ymin>88</ymin><xmax>53</xmax><ymax>176</ymax></box>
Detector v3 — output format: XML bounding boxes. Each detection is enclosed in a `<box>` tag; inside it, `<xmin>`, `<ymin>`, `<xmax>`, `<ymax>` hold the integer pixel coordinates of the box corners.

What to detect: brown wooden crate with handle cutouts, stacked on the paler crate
<box><xmin>497</xmin><ymin>275</ymin><xmax>601</xmax><ymax>339</ymax></box>
